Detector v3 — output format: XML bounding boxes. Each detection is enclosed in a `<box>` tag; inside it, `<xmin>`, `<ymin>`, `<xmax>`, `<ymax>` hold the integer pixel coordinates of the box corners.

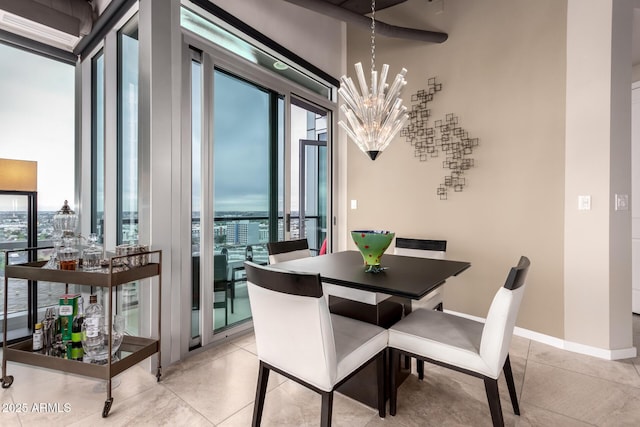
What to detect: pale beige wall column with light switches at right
<box><xmin>564</xmin><ymin>0</ymin><xmax>632</xmax><ymax>350</ymax></box>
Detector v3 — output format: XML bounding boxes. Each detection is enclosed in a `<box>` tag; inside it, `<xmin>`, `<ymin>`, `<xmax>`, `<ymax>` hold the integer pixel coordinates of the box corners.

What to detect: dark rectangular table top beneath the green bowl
<box><xmin>271</xmin><ymin>251</ymin><xmax>471</xmax><ymax>299</ymax></box>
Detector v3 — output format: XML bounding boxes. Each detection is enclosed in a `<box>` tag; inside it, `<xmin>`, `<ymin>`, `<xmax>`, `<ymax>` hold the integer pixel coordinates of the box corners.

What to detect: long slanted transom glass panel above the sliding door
<box><xmin>180</xmin><ymin>7</ymin><xmax>332</xmax><ymax>99</ymax></box>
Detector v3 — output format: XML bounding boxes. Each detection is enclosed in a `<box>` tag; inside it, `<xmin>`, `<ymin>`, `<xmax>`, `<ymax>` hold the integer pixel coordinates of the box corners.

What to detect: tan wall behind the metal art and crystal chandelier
<box><xmin>340</xmin><ymin>0</ymin><xmax>566</xmax><ymax>338</ymax></box>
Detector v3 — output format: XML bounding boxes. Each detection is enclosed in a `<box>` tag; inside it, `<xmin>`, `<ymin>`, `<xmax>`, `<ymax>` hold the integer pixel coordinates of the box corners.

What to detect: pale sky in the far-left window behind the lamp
<box><xmin>0</xmin><ymin>44</ymin><xmax>75</xmax><ymax>211</ymax></box>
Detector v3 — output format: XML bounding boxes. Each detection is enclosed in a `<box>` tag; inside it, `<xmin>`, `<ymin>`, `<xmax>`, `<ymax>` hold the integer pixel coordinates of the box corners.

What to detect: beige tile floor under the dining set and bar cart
<box><xmin>0</xmin><ymin>315</ymin><xmax>640</xmax><ymax>427</ymax></box>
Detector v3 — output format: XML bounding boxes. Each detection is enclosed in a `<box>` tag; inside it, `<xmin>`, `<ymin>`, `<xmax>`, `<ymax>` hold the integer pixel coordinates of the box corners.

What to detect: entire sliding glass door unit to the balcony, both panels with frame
<box><xmin>183</xmin><ymin>39</ymin><xmax>330</xmax><ymax>348</ymax></box>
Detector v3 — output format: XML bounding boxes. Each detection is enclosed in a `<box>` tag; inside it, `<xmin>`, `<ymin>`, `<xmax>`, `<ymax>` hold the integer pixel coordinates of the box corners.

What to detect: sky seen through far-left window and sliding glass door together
<box><xmin>0</xmin><ymin>44</ymin><xmax>316</xmax><ymax>212</ymax></box>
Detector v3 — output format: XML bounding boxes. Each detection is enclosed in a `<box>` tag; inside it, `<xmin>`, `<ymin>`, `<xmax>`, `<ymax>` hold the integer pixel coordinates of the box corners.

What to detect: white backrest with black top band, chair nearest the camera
<box><xmin>245</xmin><ymin>262</ymin><xmax>337</xmax><ymax>391</ymax></box>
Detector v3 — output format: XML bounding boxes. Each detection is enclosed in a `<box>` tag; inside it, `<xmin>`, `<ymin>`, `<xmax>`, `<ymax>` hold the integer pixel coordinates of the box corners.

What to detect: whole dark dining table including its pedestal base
<box><xmin>270</xmin><ymin>251</ymin><xmax>471</xmax><ymax>408</ymax></box>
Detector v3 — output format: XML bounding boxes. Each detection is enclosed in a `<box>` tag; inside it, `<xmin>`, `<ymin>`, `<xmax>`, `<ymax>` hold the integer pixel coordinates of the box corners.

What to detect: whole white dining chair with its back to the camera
<box><xmin>245</xmin><ymin>262</ymin><xmax>388</xmax><ymax>426</ymax></box>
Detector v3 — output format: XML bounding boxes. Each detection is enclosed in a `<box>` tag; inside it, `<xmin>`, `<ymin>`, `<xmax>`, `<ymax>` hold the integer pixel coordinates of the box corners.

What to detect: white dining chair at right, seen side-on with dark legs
<box><xmin>389</xmin><ymin>256</ymin><xmax>530</xmax><ymax>426</ymax></box>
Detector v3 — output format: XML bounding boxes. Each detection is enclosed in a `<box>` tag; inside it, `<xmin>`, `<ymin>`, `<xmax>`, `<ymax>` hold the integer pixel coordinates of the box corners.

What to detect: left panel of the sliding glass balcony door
<box><xmin>190</xmin><ymin>55</ymin><xmax>284</xmax><ymax>347</ymax></box>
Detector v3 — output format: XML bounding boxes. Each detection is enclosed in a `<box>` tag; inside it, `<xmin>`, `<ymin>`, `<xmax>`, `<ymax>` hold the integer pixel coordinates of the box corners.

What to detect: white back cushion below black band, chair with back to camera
<box><xmin>247</xmin><ymin>282</ymin><xmax>337</xmax><ymax>391</ymax></box>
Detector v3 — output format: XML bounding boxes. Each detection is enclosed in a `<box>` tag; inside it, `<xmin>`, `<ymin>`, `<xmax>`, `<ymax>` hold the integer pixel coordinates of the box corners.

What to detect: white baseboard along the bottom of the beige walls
<box><xmin>445</xmin><ymin>310</ymin><xmax>638</xmax><ymax>360</ymax></box>
